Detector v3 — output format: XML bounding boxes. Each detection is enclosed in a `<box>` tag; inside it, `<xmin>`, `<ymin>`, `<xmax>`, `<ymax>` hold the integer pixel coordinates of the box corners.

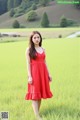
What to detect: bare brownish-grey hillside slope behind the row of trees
<box><xmin>0</xmin><ymin>2</ymin><xmax>80</xmax><ymax>28</ymax></box>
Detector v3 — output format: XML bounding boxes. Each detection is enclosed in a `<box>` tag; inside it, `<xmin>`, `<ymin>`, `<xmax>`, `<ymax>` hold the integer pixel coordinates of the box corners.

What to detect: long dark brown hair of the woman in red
<box><xmin>29</xmin><ymin>31</ymin><xmax>42</xmax><ymax>59</ymax></box>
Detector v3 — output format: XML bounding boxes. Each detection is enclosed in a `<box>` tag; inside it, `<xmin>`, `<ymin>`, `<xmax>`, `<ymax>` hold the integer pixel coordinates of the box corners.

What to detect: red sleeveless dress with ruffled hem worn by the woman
<box><xmin>25</xmin><ymin>52</ymin><xmax>53</xmax><ymax>100</ymax></box>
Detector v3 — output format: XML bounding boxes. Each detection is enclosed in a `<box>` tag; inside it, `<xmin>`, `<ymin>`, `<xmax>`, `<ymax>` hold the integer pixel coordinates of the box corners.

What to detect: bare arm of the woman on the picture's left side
<box><xmin>26</xmin><ymin>48</ymin><xmax>32</xmax><ymax>84</ymax></box>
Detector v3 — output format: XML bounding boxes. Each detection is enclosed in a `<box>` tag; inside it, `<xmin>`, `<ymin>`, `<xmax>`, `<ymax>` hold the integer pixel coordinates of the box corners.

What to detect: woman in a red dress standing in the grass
<box><xmin>25</xmin><ymin>31</ymin><xmax>53</xmax><ymax>120</ymax></box>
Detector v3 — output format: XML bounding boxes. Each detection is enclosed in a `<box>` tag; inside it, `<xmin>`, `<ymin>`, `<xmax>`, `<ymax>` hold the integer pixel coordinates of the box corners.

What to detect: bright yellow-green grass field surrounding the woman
<box><xmin>0</xmin><ymin>38</ymin><xmax>80</xmax><ymax>120</ymax></box>
